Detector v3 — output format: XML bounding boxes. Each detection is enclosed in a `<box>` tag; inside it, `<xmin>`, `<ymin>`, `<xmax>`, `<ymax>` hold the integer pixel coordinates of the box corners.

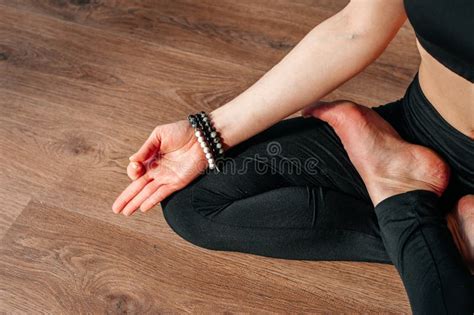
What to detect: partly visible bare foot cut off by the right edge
<box><xmin>447</xmin><ymin>195</ymin><xmax>474</xmax><ymax>273</ymax></box>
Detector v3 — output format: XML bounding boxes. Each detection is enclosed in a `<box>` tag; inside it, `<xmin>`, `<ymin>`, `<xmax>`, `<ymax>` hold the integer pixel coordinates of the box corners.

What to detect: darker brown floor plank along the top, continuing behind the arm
<box><xmin>0</xmin><ymin>0</ymin><xmax>419</xmax><ymax>106</ymax></box>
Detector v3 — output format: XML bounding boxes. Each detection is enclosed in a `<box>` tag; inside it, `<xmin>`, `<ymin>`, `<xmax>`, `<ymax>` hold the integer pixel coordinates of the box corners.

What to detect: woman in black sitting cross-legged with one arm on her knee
<box><xmin>113</xmin><ymin>0</ymin><xmax>474</xmax><ymax>314</ymax></box>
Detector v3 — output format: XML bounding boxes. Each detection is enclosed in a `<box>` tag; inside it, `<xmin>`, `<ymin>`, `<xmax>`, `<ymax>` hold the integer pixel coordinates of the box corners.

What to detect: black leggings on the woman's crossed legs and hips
<box><xmin>162</xmin><ymin>78</ymin><xmax>474</xmax><ymax>314</ymax></box>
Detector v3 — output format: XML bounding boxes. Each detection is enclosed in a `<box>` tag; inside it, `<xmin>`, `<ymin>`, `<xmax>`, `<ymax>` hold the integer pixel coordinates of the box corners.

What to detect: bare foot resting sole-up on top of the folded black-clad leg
<box><xmin>305</xmin><ymin>101</ymin><xmax>449</xmax><ymax>205</ymax></box>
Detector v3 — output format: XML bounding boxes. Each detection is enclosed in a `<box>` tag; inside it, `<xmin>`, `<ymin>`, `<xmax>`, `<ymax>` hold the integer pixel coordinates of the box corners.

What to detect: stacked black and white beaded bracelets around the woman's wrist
<box><xmin>188</xmin><ymin>111</ymin><xmax>224</xmax><ymax>171</ymax></box>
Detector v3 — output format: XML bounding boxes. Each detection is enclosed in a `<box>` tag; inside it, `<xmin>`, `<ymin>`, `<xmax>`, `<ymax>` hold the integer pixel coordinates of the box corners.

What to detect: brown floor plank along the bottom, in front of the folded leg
<box><xmin>0</xmin><ymin>202</ymin><xmax>409</xmax><ymax>313</ymax></box>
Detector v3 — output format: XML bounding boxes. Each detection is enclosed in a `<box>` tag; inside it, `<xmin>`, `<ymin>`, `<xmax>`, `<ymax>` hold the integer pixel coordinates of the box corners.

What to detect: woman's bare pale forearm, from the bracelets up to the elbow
<box><xmin>211</xmin><ymin>3</ymin><xmax>404</xmax><ymax>147</ymax></box>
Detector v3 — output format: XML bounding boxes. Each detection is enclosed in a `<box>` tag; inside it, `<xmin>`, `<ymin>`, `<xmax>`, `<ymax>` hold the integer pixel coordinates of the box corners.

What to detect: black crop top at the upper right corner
<box><xmin>404</xmin><ymin>0</ymin><xmax>474</xmax><ymax>82</ymax></box>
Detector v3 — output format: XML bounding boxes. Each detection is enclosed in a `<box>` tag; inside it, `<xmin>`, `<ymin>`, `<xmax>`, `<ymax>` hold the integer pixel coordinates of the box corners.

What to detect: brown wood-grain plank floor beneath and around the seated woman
<box><xmin>0</xmin><ymin>0</ymin><xmax>419</xmax><ymax>313</ymax></box>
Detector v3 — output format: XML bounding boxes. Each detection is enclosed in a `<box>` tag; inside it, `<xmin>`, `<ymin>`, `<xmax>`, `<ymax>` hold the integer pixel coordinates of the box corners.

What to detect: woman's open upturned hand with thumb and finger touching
<box><xmin>112</xmin><ymin>120</ymin><xmax>207</xmax><ymax>216</ymax></box>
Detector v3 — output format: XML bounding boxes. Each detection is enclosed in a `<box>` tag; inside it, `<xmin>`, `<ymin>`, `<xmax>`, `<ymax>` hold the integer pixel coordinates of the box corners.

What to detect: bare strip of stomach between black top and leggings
<box><xmin>417</xmin><ymin>42</ymin><xmax>474</xmax><ymax>139</ymax></box>
